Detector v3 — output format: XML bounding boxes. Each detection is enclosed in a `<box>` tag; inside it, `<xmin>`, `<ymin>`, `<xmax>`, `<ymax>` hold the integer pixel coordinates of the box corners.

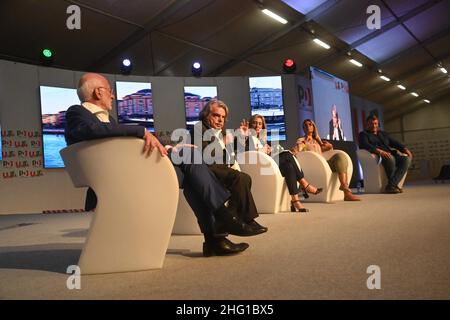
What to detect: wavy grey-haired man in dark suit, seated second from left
<box><xmin>194</xmin><ymin>99</ymin><xmax>267</xmax><ymax>233</ymax></box>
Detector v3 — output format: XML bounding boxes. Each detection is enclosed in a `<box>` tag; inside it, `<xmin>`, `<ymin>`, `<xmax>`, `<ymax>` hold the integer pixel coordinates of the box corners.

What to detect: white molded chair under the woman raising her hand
<box><xmin>238</xmin><ymin>151</ymin><xmax>290</xmax><ymax>213</ymax></box>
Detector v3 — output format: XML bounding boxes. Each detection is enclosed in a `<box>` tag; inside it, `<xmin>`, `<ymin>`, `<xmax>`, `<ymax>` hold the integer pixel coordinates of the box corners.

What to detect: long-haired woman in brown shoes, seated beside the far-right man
<box><xmin>297</xmin><ymin>119</ymin><xmax>361</xmax><ymax>201</ymax></box>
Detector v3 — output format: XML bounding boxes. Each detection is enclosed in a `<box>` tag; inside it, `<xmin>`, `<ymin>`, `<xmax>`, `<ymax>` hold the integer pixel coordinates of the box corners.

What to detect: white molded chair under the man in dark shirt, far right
<box><xmin>357</xmin><ymin>149</ymin><xmax>408</xmax><ymax>193</ymax></box>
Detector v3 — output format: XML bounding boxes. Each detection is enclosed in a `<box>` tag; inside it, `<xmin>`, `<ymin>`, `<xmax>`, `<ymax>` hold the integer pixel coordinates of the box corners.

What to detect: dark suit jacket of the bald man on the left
<box><xmin>65</xmin><ymin>105</ymin><xmax>145</xmax><ymax>145</ymax></box>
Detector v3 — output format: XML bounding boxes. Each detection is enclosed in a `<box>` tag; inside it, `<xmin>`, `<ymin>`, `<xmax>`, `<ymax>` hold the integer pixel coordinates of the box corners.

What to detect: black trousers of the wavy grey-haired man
<box><xmin>209</xmin><ymin>164</ymin><xmax>258</xmax><ymax>222</ymax></box>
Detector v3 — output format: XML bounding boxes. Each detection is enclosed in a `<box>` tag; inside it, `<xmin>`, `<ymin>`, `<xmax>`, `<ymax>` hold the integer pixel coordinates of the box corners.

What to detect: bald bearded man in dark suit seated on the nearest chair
<box><xmin>65</xmin><ymin>73</ymin><xmax>257</xmax><ymax>256</ymax></box>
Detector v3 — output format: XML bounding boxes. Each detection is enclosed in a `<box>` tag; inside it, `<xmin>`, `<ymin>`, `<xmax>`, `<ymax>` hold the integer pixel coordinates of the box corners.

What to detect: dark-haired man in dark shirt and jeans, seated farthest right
<box><xmin>359</xmin><ymin>115</ymin><xmax>412</xmax><ymax>193</ymax></box>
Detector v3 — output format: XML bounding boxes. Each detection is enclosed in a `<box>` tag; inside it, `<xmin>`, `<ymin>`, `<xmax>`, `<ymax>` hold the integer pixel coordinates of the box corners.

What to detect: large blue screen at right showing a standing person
<box><xmin>310</xmin><ymin>67</ymin><xmax>353</xmax><ymax>141</ymax></box>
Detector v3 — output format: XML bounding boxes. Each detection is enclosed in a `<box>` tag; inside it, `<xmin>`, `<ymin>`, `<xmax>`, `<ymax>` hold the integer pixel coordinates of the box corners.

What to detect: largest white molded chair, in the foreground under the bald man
<box><xmin>60</xmin><ymin>137</ymin><xmax>178</xmax><ymax>274</ymax></box>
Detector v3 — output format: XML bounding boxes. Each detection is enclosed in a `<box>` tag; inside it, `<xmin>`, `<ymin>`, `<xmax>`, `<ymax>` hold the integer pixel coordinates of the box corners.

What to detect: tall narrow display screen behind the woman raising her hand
<box><xmin>249</xmin><ymin>76</ymin><xmax>286</xmax><ymax>141</ymax></box>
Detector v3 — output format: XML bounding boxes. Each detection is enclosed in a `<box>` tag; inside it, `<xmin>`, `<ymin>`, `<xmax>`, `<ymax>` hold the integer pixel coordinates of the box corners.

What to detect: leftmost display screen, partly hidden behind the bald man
<box><xmin>39</xmin><ymin>86</ymin><xmax>80</xmax><ymax>169</ymax></box>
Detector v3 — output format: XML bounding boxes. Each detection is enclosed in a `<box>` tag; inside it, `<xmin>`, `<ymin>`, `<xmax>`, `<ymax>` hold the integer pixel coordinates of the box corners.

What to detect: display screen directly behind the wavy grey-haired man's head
<box><xmin>184</xmin><ymin>86</ymin><xmax>217</xmax><ymax>131</ymax></box>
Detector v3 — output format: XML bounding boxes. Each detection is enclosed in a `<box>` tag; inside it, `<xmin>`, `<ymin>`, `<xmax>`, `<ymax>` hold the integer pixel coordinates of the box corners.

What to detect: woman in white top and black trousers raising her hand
<box><xmin>239</xmin><ymin>114</ymin><xmax>322</xmax><ymax>212</ymax></box>
